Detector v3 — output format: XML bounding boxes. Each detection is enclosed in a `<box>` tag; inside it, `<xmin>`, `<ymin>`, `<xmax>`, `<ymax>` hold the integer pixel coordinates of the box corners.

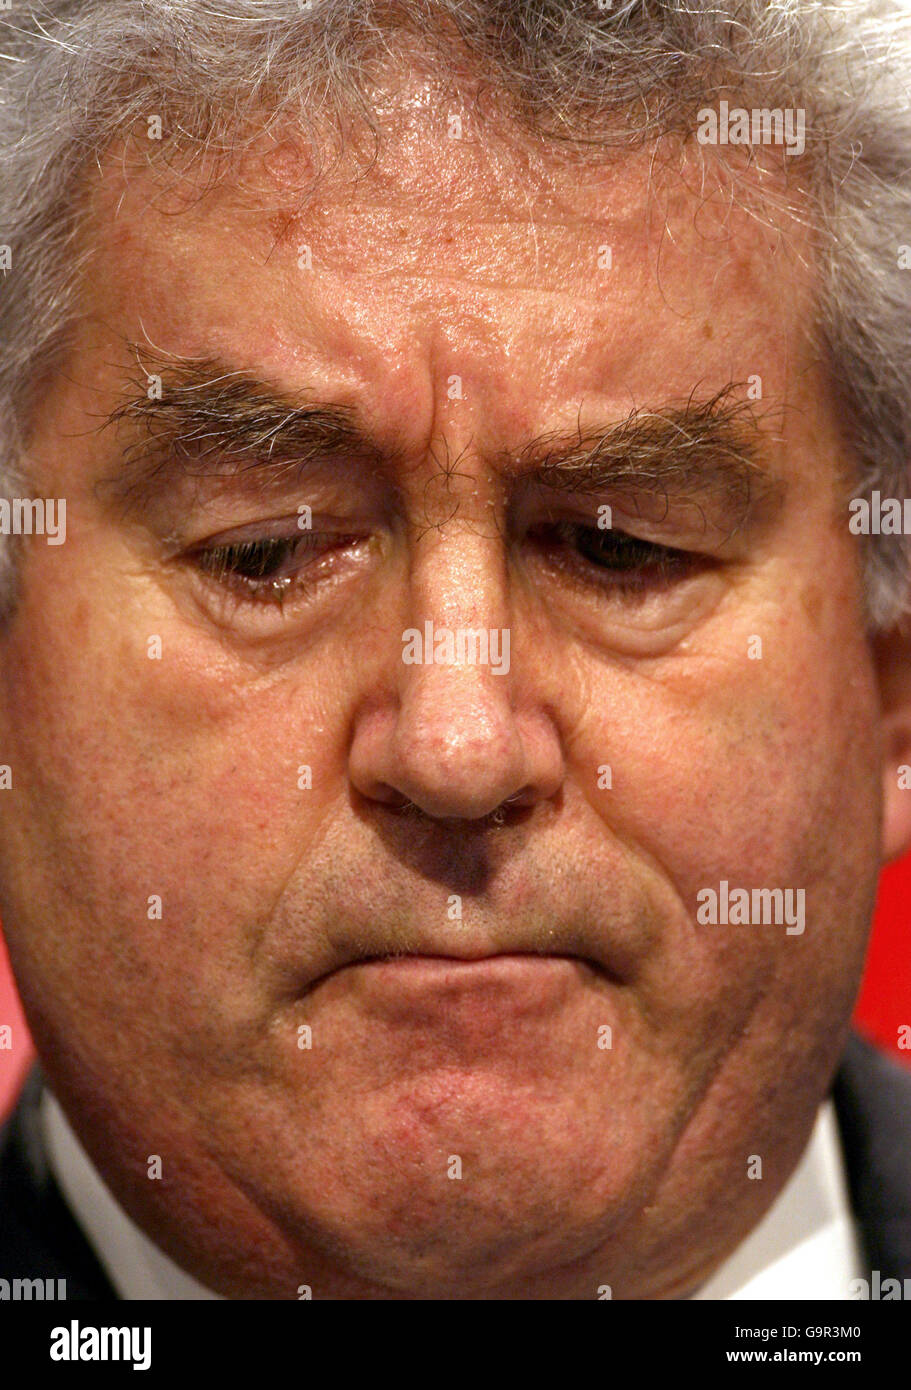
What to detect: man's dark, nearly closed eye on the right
<box><xmin>530</xmin><ymin>521</ymin><xmax>700</xmax><ymax>594</ymax></box>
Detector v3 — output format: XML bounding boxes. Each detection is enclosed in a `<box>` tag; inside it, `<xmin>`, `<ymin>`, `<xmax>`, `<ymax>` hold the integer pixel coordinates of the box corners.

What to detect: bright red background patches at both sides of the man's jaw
<box><xmin>0</xmin><ymin>855</ymin><xmax>911</xmax><ymax>1119</ymax></box>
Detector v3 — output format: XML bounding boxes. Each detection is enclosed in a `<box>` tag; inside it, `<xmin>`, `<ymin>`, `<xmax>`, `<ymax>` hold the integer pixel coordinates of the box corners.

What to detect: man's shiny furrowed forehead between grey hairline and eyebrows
<box><xmin>76</xmin><ymin>76</ymin><xmax>812</xmax><ymax>455</ymax></box>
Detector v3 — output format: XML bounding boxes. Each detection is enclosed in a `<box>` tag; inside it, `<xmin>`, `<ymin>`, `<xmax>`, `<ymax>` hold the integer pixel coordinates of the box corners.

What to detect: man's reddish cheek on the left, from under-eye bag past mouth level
<box><xmin>0</xmin><ymin>569</ymin><xmax>344</xmax><ymax>1049</ymax></box>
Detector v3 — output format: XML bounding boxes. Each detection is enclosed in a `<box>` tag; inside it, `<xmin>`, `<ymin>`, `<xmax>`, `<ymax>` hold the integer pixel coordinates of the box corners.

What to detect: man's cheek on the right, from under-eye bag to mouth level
<box><xmin>580</xmin><ymin>589</ymin><xmax>879</xmax><ymax>1030</ymax></box>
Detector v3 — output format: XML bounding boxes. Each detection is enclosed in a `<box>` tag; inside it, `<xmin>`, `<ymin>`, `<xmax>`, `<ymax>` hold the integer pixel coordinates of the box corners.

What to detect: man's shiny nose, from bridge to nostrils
<box><xmin>349</xmin><ymin>535</ymin><xmax>563</xmax><ymax>820</ymax></box>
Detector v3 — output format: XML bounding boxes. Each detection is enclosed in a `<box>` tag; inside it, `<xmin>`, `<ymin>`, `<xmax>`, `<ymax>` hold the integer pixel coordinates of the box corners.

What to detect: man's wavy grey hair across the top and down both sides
<box><xmin>0</xmin><ymin>0</ymin><xmax>911</xmax><ymax>627</ymax></box>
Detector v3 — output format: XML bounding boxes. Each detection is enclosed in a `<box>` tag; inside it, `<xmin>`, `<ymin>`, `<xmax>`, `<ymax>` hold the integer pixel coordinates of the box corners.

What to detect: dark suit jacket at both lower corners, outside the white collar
<box><xmin>0</xmin><ymin>1034</ymin><xmax>911</xmax><ymax>1300</ymax></box>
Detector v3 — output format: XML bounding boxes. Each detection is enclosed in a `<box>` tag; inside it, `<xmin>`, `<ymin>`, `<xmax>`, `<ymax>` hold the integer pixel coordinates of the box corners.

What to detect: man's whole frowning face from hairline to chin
<box><xmin>0</xmin><ymin>86</ymin><xmax>882</xmax><ymax>1298</ymax></box>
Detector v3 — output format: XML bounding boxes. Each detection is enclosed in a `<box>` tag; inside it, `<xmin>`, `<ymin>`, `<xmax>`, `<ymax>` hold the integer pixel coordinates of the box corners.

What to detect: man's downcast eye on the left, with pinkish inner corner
<box><xmin>186</xmin><ymin>532</ymin><xmax>357</xmax><ymax>603</ymax></box>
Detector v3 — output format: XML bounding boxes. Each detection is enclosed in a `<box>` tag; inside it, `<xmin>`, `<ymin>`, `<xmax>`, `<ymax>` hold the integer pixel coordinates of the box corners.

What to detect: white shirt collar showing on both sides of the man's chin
<box><xmin>40</xmin><ymin>1088</ymin><xmax>864</xmax><ymax>1301</ymax></box>
